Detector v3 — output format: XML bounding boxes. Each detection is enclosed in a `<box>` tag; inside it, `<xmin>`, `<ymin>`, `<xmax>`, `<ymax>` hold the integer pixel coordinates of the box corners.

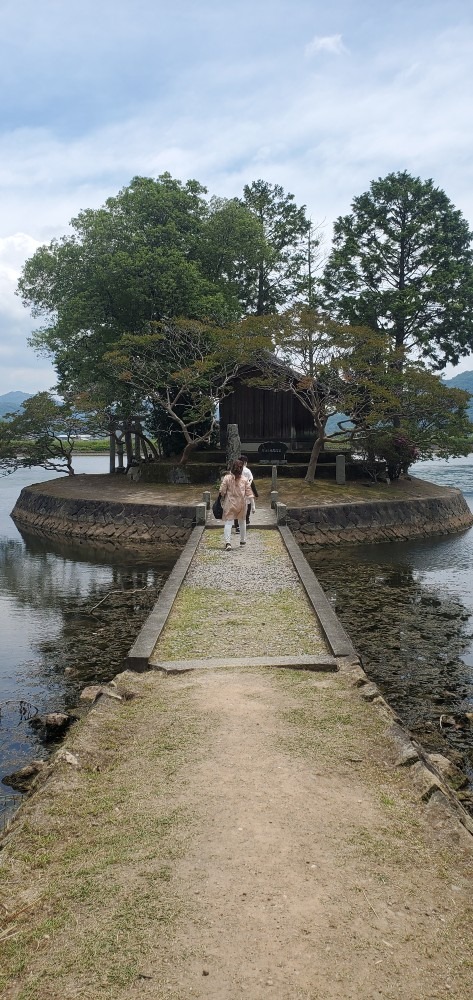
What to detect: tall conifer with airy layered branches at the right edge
<box><xmin>322</xmin><ymin>171</ymin><xmax>473</xmax><ymax>368</ymax></box>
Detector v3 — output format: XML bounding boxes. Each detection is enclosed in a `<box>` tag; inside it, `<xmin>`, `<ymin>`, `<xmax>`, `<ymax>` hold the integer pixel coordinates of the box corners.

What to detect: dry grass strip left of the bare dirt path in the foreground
<box><xmin>0</xmin><ymin>675</ymin><xmax>208</xmax><ymax>1000</ymax></box>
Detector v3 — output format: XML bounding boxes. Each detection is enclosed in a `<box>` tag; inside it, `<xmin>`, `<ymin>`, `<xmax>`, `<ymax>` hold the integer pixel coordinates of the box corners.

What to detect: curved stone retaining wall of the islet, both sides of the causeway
<box><xmin>12</xmin><ymin>487</ymin><xmax>473</xmax><ymax>548</ymax></box>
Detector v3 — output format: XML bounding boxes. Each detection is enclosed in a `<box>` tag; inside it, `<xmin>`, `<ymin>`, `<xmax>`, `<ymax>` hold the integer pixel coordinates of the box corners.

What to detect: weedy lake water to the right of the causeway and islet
<box><xmin>310</xmin><ymin>455</ymin><xmax>473</xmax><ymax>778</ymax></box>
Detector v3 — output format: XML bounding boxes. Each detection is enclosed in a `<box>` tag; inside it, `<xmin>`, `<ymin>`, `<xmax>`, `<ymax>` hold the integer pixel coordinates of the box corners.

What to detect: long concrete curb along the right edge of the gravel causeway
<box><xmin>278</xmin><ymin>525</ymin><xmax>359</xmax><ymax>662</ymax></box>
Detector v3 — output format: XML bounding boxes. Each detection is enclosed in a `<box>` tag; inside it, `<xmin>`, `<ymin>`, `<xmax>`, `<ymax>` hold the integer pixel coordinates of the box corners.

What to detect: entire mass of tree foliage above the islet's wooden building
<box><xmin>13</xmin><ymin>172</ymin><xmax>473</xmax><ymax>479</ymax></box>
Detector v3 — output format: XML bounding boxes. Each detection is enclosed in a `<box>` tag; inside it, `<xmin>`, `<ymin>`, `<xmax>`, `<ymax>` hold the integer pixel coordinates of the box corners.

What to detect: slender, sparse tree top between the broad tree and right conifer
<box><xmin>241</xmin><ymin>180</ymin><xmax>318</xmax><ymax>316</ymax></box>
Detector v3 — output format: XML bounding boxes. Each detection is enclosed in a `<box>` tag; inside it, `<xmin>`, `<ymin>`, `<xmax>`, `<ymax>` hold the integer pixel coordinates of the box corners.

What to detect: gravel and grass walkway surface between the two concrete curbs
<box><xmin>152</xmin><ymin>529</ymin><xmax>328</xmax><ymax>662</ymax></box>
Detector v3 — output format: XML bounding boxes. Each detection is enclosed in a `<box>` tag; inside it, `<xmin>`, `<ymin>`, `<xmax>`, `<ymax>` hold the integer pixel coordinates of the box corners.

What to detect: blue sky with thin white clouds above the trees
<box><xmin>0</xmin><ymin>0</ymin><xmax>473</xmax><ymax>394</ymax></box>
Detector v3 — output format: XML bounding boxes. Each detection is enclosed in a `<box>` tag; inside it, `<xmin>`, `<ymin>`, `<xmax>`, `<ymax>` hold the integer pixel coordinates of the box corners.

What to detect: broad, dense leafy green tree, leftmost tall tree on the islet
<box><xmin>18</xmin><ymin>174</ymin><xmax>261</xmax><ymax>402</ymax></box>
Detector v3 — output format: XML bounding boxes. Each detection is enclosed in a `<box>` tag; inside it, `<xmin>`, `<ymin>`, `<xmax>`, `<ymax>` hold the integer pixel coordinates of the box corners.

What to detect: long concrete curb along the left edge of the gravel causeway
<box><xmin>126</xmin><ymin>525</ymin><xmax>205</xmax><ymax>672</ymax></box>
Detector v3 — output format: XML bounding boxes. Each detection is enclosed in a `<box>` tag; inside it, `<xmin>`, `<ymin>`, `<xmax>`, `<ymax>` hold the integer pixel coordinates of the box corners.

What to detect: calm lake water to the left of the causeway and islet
<box><xmin>0</xmin><ymin>456</ymin><xmax>170</xmax><ymax>828</ymax></box>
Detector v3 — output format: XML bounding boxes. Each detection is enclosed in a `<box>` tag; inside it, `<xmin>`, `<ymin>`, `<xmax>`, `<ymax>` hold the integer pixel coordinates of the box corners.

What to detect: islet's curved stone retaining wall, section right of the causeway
<box><xmin>286</xmin><ymin>488</ymin><xmax>473</xmax><ymax>549</ymax></box>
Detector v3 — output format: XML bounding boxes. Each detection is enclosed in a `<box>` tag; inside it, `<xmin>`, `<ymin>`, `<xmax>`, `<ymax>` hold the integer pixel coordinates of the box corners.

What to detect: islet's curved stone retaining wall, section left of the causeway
<box><xmin>12</xmin><ymin>487</ymin><xmax>196</xmax><ymax>547</ymax></box>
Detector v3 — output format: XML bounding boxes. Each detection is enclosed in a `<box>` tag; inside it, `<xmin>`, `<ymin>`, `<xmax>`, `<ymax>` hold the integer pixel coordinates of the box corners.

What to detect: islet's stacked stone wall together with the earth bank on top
<box><xmin>12</xmin><ymin>476</ymin><xmax>473</xmax><ymax>549</ymax></box>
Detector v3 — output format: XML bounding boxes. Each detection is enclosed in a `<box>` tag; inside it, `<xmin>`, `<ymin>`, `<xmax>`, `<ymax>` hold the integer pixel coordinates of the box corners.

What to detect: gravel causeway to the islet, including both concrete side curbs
<box><xmin>128</xmin><ymin>510</ymin><xmax>356</xmax><ymax>673</ymax></box>
